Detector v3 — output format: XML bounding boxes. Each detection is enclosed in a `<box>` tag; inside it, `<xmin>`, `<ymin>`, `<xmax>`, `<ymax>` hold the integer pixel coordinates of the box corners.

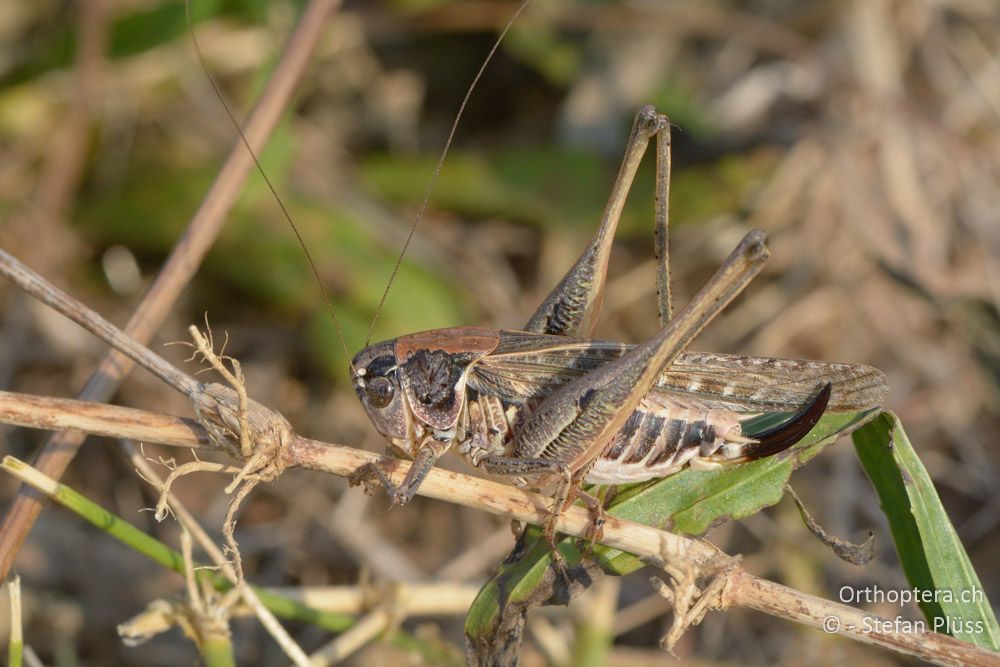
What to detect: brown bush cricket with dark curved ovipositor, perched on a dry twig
<box><xmin>351</xmin><ymin>106</ymin><xmax>888</xmax><ymax>544</ymax></box>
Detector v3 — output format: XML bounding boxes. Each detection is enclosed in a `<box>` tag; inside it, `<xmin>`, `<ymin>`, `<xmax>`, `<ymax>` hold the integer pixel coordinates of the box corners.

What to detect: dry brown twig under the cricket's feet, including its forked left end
<box><xmin>0</xmin><ymin>250</ymin><xmax>1000</xmax><ymax>665</ymax></box>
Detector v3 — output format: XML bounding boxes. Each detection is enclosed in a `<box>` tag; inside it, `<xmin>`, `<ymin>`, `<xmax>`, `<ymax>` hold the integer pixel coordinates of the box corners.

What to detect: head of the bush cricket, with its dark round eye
<box><xmin>352</xmin><ymin>340</ymin><xmax>408</xmax><ymax>440</ymax></box>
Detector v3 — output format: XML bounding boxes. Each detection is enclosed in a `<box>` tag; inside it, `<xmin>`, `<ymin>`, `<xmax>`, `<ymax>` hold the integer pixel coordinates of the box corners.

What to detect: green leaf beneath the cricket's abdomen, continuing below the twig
<box><xmin>465</xmin><ymin>411</ymin><xmax>876</xmax><ymax>645</ymax></box>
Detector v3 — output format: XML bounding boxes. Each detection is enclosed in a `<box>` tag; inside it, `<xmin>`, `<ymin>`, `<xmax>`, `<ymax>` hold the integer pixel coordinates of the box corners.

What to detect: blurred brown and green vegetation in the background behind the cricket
<box><xmin>0</xmin><ymin>0</ymin><xmax>1000</xmax><ymax>665</ymax></box>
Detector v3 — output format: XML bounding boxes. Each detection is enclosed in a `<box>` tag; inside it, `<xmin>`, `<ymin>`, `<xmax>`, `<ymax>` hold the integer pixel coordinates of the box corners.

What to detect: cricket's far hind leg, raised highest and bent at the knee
<box><xmin>524</xmin><ymin>106</ymin><xmax>670</xmax><ymax>338</ymax></box>
